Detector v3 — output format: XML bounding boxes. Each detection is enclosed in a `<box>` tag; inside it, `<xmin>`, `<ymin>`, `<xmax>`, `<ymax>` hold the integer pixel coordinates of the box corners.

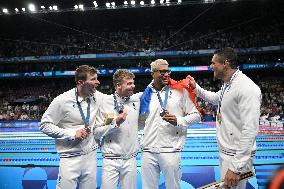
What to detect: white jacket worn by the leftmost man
<box><xmin>40</xmin><ymin>88</ymin><xmax>102</xmax><ymax>157</ymax></box>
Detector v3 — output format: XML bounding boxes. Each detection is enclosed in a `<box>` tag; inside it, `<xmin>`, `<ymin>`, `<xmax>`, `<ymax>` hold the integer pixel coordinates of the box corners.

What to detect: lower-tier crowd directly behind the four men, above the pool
<box><xmin>0</xmin><ymin>76</ymin><xmax>284</xmax><ymax>121</ymax></box>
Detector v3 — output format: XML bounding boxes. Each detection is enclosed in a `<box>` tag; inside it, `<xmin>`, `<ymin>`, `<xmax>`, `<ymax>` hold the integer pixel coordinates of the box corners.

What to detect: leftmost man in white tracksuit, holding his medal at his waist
<box><xmin>40</xmin><ymin>65</ymin><xmax>101</xmax><ymax>189</ymax></box>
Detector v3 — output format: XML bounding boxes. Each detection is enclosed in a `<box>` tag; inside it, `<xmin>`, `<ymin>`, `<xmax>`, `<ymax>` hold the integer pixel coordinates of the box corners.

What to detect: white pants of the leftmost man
<box><xmin>56</xmin><ymin>150</ymin><xmax>97</xmax><ymax>189</ymax></box>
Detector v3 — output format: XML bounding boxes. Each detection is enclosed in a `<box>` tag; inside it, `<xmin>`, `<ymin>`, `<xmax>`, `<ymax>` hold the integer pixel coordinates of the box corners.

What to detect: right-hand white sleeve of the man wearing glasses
<box><xmin>177</xmin><ymin>90</ymin><xmax>201</xmax><ymax>127</ymax></box>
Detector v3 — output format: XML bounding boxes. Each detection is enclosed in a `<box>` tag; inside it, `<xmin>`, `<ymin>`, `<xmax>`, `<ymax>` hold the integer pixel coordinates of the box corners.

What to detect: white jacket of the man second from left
<box><xmin>94</xmin><ymin>93</ymin><xmax>142</xmax><ymax>159</ymax></box>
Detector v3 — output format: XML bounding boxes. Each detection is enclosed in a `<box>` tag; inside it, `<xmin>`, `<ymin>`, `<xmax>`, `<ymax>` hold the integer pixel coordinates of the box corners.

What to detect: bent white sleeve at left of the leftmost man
<box><xmin>40</xmin><ymin>98</ymin><xmax>76</xmax><ymax>140</ymax></box>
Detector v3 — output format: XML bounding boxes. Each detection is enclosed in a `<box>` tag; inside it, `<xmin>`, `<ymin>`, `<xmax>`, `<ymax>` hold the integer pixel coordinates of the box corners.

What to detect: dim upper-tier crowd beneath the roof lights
<box><xmin>0</xmin><ymin>20</ymin><xmax>284</xmax><ymax>57</ymax></box>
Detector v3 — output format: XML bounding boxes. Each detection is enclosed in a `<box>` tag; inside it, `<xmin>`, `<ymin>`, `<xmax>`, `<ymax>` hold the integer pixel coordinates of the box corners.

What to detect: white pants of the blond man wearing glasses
<box><xmin>141</xmin><ymin>152</ymin><xmax>181</xmax><ymax>189</ymax></box>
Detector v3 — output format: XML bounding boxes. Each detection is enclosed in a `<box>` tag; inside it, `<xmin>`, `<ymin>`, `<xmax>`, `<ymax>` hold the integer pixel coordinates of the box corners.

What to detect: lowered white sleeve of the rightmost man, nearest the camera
<box><xmin>229</xmin><ymin>87</ymin><xmax>261</xmax><ymax>172</ymax></box>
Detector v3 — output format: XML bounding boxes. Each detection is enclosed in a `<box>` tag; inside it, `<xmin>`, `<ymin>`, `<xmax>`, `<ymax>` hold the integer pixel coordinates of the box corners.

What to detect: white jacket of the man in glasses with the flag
<box><xmin>141</xmin><ymin>84</ymin><xmax>201</xmax><ymax>153</ymax></box>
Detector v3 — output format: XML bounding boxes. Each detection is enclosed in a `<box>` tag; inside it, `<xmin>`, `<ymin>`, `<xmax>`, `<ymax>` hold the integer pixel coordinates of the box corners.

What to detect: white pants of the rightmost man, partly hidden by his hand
<box><xmin>219</xmin><ymin>152</ymin><xmax>254</xmax><ymax>189</ymax></box>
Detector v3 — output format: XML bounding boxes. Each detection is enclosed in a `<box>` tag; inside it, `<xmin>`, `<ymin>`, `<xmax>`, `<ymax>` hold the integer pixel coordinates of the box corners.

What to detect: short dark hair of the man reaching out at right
<box><xmin>214</xmin><ymin>47</ymin><xmax>239</xmax><ymax>69</ymax></box>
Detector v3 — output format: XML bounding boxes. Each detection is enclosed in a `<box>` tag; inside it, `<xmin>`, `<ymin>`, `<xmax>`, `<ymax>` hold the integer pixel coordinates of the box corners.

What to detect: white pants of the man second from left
<box><xmin>100</xmin><ymin>157</ymin><xmax>137</xmax><ymax>189</ymax></box>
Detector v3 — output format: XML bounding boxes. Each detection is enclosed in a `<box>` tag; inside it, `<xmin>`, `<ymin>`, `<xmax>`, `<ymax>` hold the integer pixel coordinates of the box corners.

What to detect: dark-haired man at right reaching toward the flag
<box><xmin>189</xmin><ymin>48</ymin><xmax>261</xmax><ymax>189</ymax></box>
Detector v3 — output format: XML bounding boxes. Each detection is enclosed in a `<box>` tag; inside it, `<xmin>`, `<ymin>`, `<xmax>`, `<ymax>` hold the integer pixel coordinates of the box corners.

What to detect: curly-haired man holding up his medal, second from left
<box><xmin>94</xmin><ymin>69</ymin><xmax>141</xmax><ymax>189</ymax></box>
